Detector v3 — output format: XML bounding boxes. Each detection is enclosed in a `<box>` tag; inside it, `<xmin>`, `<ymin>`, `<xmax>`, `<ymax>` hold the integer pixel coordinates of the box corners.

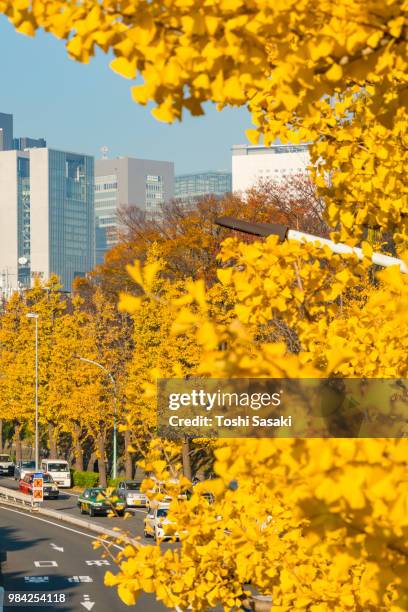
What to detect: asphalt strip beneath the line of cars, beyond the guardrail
<box><xmin>0</xmin><ymin>477</ymin><xmax>148</xmax><ymax>544</ymax></box>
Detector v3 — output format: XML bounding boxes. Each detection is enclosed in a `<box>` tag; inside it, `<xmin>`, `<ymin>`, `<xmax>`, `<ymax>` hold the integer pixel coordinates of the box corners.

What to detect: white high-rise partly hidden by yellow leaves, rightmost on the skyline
<box><xmin>232</xmin><ymin>144</ymin><xmax>310</xmax><ymax>192</ymax></box>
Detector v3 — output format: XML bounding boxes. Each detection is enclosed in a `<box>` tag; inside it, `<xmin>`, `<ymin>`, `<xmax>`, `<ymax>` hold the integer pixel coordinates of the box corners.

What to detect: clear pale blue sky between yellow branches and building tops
<box><xmin>0</xmin><ymin>16</ymin><xmax>251</xmax><ymax>173</ymax></box>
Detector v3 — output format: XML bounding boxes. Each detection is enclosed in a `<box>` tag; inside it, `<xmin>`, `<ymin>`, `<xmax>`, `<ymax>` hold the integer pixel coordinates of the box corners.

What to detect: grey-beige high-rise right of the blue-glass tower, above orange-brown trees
<box><xmin>95</xmin><ymin>157</ymin><xmax>174</xmax><ymax>263</ymax></box>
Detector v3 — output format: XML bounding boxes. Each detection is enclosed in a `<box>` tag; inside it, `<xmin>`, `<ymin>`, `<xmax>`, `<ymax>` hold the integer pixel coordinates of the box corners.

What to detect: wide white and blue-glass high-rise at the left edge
<box><xmin>0</xmin><ymin>148</ymin><xmax>94</xmax><ymax>293</ymax></box>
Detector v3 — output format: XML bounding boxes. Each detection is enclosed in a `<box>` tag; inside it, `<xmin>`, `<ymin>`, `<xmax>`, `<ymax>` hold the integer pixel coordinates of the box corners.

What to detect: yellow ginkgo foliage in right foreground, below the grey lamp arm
<box><xmin>106</xmin><ymin>245</ymin><xmax>408</xmax><ymax>612</ymax></box>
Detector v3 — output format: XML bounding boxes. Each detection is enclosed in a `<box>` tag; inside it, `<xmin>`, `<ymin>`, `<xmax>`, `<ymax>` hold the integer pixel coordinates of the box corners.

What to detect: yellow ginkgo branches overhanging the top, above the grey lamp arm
<box><xmin>0</xmin><ymin>0</ymin><xmax>408</xmax><ymax>242</ymax></box>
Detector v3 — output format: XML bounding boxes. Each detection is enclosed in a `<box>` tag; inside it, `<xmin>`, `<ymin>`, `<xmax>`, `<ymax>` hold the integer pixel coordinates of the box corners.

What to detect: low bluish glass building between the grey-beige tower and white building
<box><xmin>174</xmin><ymin>171</ymin><xmax>232</xmax><ymax>204</ymax></box>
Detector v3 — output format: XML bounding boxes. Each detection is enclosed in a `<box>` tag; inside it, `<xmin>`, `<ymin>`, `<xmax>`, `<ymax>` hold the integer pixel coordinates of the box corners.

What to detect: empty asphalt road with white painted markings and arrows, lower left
<box><xmin>0</xmin><ymin>504</ymin><xmax>166</xmax><ymax>612</ymax></box>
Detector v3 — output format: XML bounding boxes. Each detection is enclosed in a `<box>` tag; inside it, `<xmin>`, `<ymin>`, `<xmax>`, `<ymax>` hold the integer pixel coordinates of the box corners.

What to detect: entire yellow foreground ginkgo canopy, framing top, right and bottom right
<box><xmin>0</xmin><ymin>0</ymin><xmax>408</xmax><ymax>612</ymax></box>
